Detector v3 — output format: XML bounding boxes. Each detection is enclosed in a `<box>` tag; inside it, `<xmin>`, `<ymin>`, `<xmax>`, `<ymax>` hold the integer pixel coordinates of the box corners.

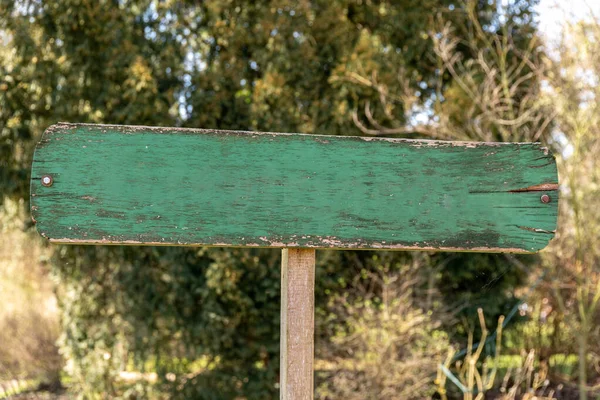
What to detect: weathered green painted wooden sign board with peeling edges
<box><xmin>31</xmin><ymin>123</ymin><xmax>558</xmax><ymax>252</ymax></box>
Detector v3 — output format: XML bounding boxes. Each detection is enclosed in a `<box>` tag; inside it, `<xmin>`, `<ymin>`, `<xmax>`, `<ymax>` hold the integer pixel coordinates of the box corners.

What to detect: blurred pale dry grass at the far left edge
<box><xmin>0</xmin><ymin>201</ymin><xmax>62</xmax><ymax>382</ymax></box>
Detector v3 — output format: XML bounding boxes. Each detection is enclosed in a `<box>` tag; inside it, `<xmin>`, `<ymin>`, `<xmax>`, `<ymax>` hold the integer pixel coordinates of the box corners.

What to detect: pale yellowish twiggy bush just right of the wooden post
<box><xmin>316</xmin><ymin>253</ymin><xmax>449</xmax><ymax>400</ymax></box>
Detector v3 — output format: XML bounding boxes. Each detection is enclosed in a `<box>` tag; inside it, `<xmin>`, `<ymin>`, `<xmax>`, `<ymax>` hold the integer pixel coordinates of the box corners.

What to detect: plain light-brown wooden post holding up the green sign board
<box><xmin>279</xmin><ymin>249</ymin><xmax>315</xmax><ymax>400</ymax></box>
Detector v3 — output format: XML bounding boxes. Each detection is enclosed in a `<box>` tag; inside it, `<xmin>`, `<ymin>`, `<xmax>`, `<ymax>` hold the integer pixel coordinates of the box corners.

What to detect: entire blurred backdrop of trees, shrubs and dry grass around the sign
<box><xmin>0</xmin><ymin>0</ymin><xmax>600</xmax><ymax>399</ymax></box>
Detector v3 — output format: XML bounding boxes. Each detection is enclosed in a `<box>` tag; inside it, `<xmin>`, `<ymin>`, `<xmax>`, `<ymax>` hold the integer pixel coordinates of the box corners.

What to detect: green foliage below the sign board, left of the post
<box><xmin>51</xmin><ymin>247</ymin><xmax>279</xmax><ymax>398</ymax></box>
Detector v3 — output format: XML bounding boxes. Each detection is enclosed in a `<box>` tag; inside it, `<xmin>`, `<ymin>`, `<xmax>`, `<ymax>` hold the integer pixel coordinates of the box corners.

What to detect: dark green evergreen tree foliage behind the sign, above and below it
<box><xmin>0</xmin><ymin>0</ymin><xmax>544</xmax><ymax>399</ymax></box>
